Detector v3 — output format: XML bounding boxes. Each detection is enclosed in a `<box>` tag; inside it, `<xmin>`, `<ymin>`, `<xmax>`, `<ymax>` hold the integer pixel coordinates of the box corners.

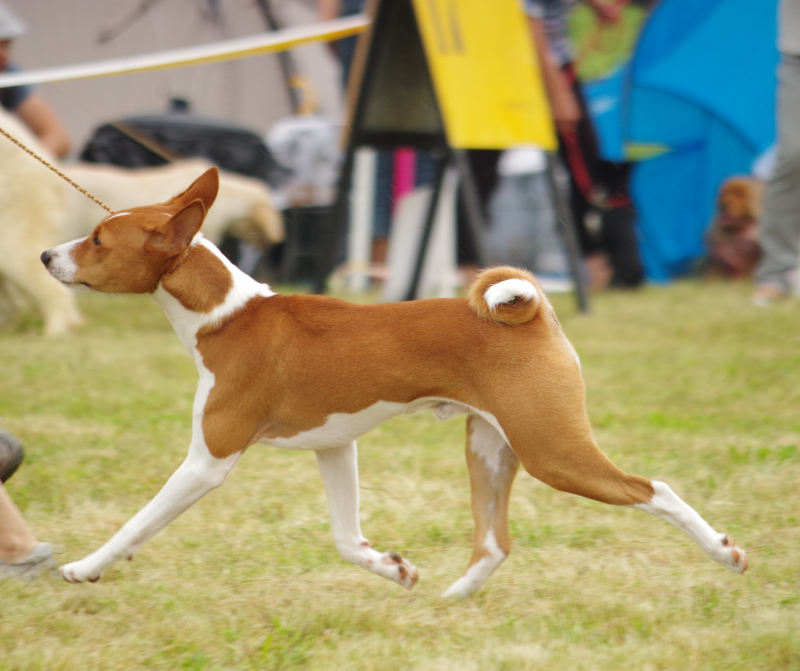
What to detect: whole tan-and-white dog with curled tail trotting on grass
<box><xmin>42</xmin><ymin>170</ymin><xmax>747</xmax><ymax>597</ymax></box>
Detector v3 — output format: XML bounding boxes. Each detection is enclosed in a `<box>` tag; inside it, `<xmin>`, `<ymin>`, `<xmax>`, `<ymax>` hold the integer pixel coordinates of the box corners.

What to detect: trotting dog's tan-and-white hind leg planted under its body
<box><xmin>442</xmin><ymin>415</ymin><xmax>519</xmax><ymax>598</ymax></box>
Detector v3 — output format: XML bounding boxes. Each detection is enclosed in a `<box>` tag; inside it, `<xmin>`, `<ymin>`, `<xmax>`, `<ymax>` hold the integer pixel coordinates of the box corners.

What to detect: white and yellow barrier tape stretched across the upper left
<box><xmin>0</xmin><ymin>14</ymin><xmax>370</xmax><ymax>88</ymax></box>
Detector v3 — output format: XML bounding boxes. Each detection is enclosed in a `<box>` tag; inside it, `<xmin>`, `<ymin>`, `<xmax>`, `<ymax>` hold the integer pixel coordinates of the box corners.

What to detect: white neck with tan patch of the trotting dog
<box><xmin>152</xmin><ymin>235</ymin><xmax>275</xmax><ymax>353</ymax></box>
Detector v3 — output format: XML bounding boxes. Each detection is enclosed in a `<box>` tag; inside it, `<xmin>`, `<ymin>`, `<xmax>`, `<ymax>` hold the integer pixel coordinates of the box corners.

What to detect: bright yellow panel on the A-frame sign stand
<box><xmin>413</xmin><ymin>0</ymin><xmax>557</xmax><ymax>149</ymax></box>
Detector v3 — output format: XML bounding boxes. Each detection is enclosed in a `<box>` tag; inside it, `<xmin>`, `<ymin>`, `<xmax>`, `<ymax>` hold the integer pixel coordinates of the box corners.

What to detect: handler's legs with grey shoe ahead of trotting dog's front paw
<box><xmin>0</xmin><ymin>429</ymin><xmax>54</xmax><ymax>579</ymax></box>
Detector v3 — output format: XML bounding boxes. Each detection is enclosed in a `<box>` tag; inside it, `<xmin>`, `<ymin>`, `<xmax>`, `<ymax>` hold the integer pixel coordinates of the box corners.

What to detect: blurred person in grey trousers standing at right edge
<box><xmin>753</xmin><ymin>0</ymin><xmax>800</xmax><ymax>305</ymax></box>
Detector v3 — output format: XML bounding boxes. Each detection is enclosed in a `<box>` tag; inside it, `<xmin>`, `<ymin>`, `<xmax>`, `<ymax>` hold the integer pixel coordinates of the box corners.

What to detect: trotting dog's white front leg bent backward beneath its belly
<box><xmin>316</xmin><ymin>442</ymin><xmax>419</xmax><ymax>589</ymax></box>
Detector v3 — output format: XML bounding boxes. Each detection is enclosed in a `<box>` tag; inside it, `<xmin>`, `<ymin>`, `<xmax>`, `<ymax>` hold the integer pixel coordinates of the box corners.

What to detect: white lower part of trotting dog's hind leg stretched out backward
<box><xmin>633</xmin><ymin>480</ymin><xmax>748</xmax><ymax>573</ymax></box>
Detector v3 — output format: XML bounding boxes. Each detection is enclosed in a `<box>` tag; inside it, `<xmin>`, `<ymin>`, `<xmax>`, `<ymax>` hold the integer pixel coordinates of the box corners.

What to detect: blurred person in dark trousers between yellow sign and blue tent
<box><xmin>525</xmin><ymin>0</ymin><xmax>644</xmax><ymax>288</ymax></box>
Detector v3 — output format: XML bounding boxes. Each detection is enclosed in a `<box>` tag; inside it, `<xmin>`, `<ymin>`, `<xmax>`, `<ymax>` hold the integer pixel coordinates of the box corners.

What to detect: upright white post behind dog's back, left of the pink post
<box><xmin>347</xmin><ymin>147</ymin><xmax>378</xmax><ymax>292</ymax></box>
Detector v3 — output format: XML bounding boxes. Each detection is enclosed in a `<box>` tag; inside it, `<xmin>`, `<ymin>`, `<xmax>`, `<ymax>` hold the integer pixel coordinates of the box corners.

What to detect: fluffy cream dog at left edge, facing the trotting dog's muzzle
<box><xmin>0</xmin><ymin>108</ymin><xmax>81</xmax><ymax>336</ymax></box>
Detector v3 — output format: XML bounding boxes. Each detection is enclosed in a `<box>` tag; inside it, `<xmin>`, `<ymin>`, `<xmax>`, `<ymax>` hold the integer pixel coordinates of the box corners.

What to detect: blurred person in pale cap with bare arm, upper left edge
<box><xmin>0</xmin><ymin>3</ymin><xmax>70</xmax><ymax>158</ymax></box>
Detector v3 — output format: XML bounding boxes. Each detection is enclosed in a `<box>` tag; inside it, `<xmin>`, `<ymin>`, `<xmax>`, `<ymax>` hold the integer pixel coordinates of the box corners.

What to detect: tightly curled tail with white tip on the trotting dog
<box><xmin>469</xmin><ymin>266</ymin><xmax>542</xmax><ymax>326</ymax></box>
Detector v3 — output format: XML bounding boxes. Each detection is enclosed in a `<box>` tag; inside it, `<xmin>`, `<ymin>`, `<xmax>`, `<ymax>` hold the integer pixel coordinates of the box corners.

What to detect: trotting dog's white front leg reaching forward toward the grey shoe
<box><xmin>60</xmin><ymin>440</ymin><xmax>242</xmax><ymax>582</ymax></box>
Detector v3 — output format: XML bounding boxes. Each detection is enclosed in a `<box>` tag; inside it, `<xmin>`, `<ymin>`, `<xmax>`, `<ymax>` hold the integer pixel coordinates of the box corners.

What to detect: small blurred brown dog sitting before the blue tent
<box><xmin>705</xmin><ymin>177</ymin><xmax>764</xmax><ymax>279</ymax></box>
